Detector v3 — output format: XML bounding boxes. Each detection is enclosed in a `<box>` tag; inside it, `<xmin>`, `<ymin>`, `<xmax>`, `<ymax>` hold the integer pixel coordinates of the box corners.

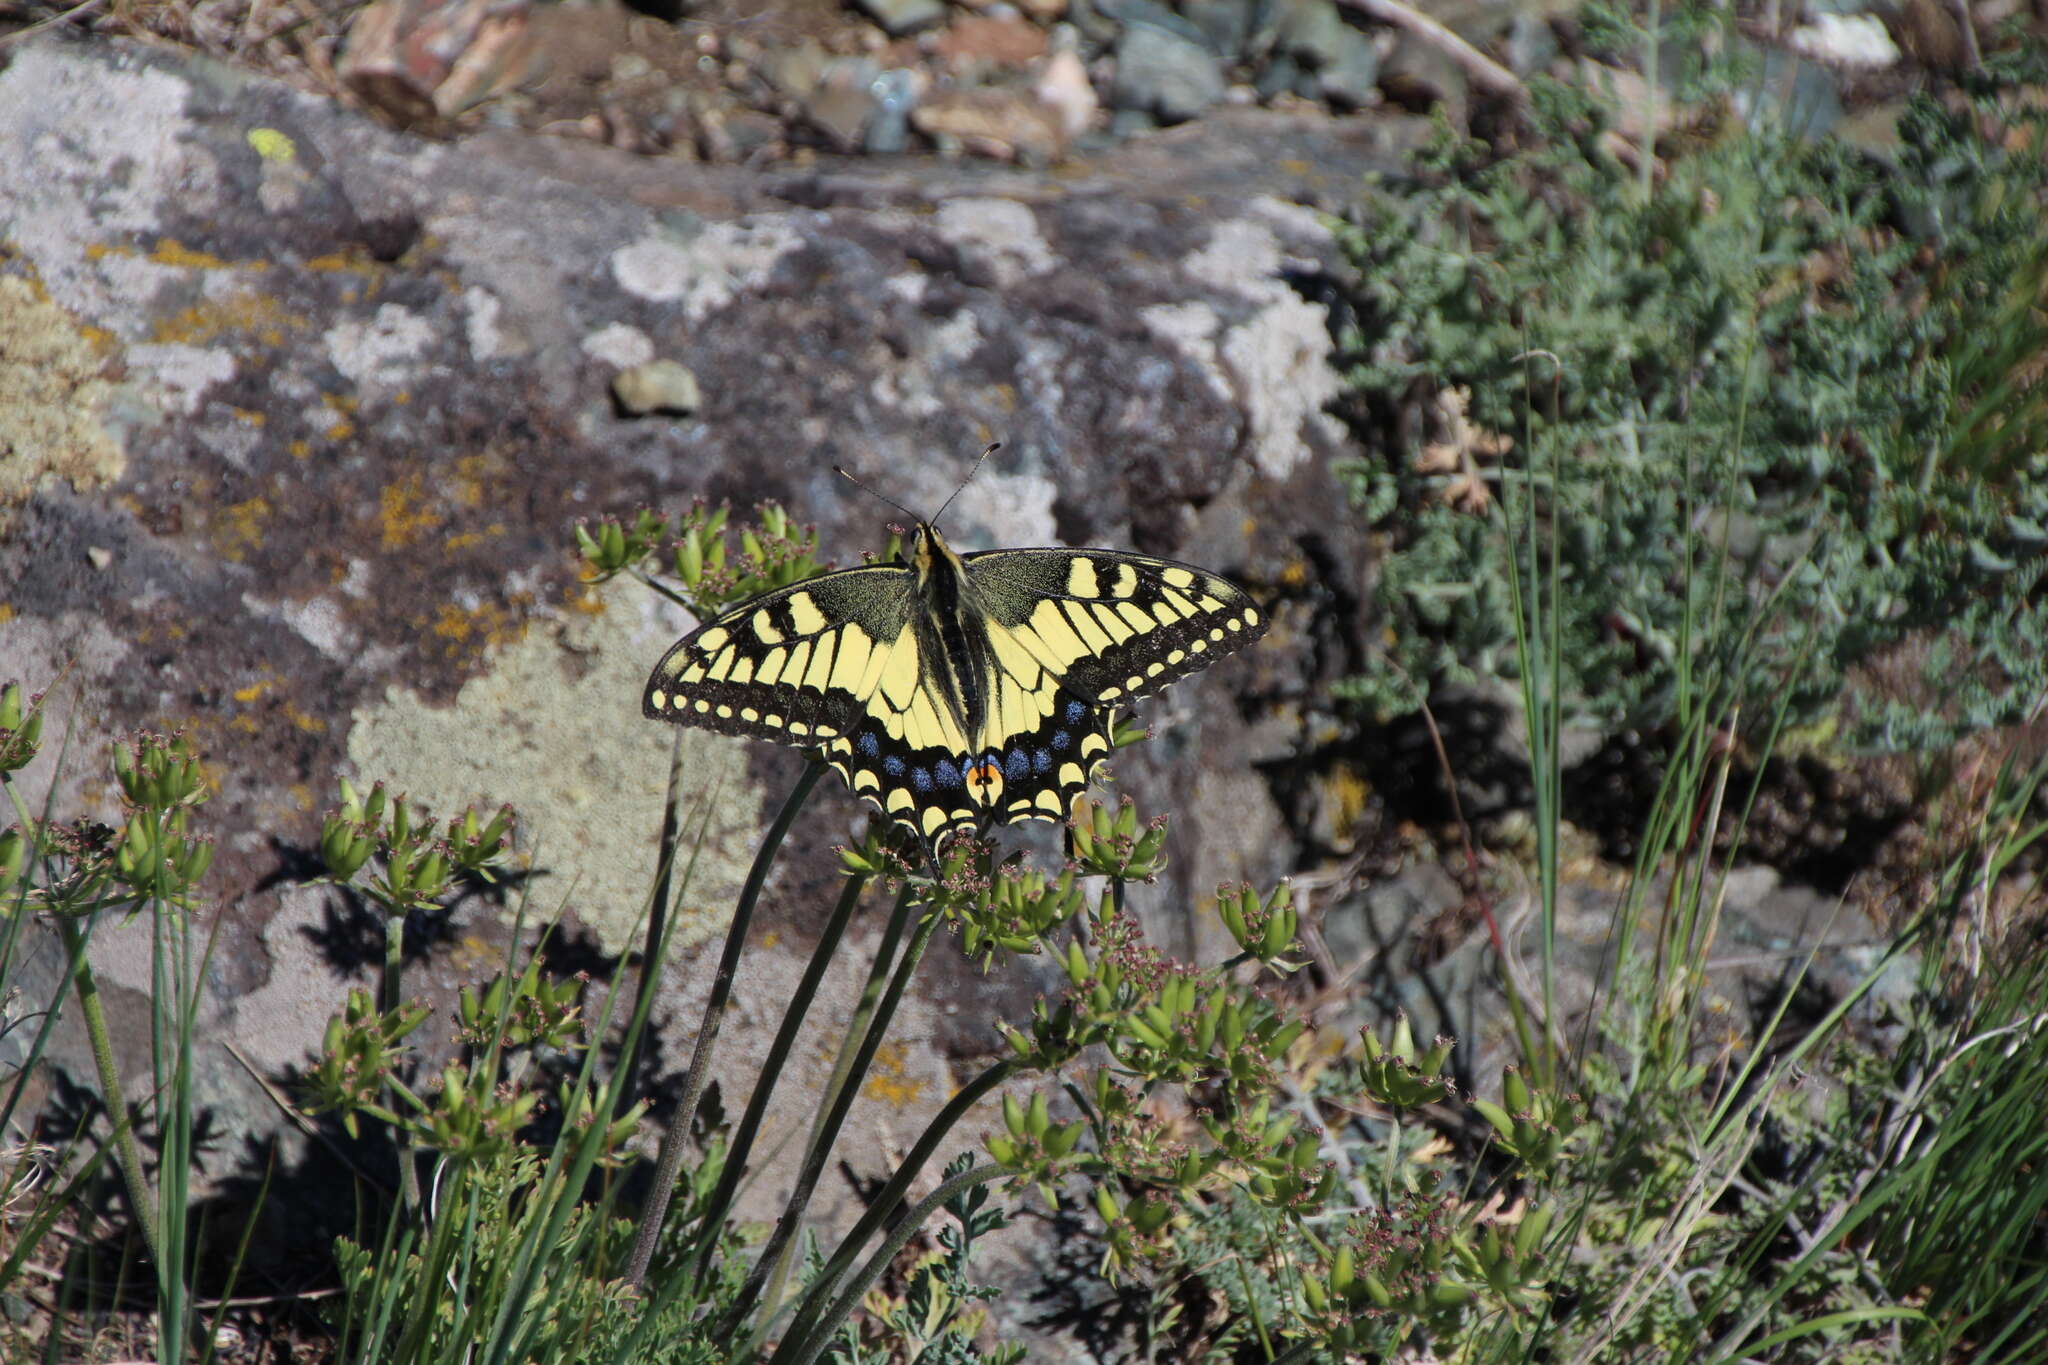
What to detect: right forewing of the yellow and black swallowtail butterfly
<box><xmin>965</xmin><ymin>548</ymin><xmax>1266</xmax><ymax>706</ymax></box>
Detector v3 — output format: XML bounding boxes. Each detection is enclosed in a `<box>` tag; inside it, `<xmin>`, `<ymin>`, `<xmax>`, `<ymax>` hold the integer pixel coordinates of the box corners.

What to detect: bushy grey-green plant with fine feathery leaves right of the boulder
<box><xmin>1339</xmin><ymin>37</ymin><xmax>2048</xmax><ymax>749</ymax></box>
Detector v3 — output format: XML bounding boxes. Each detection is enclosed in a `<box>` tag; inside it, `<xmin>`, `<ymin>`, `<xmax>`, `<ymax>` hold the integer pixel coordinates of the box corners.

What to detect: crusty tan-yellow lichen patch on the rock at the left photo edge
<box><xmin>0</xmin><ymin>276</ymin><xmax>127</xmax><ymax>532</ymax></box>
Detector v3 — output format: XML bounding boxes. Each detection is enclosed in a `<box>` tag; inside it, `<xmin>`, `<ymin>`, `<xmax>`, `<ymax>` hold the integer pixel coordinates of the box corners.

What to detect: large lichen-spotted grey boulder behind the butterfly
<box><xmin>0</xmin><ymin>37</ymin><xmax>1389</xmax><ymax>1268</ymax></box>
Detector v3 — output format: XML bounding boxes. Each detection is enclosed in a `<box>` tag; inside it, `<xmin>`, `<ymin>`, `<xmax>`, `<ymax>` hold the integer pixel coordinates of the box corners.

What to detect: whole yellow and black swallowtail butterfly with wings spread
<box><xmin>643</xmin><ymin>524</ymin><xmax>1266</xmax><ymax>845</ymax></box>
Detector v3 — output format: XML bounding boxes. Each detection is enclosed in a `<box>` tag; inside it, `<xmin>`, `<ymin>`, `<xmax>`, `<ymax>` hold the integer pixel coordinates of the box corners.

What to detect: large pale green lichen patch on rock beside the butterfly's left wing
<box><xmin>348</xmin><ymin>589</ymin><xmax>760</xmax><ymax>954</ymax></box>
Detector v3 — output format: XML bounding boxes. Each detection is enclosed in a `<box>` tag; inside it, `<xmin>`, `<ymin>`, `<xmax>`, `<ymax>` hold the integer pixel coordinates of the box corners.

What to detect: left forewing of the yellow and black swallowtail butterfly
<box><xmin>643</xmin><ymin>567</ymin><xmax>918</xmax><ymax>747</ymax></box>
